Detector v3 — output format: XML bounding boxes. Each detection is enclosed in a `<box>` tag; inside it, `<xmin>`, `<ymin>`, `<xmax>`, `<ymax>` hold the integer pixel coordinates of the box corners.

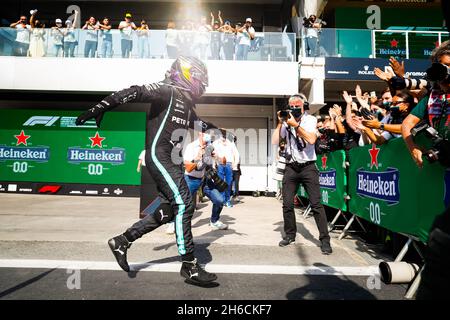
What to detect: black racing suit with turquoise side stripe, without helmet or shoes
<box><xmin>90</xmin><ymin>79</ymin><xmax>216</xmax><ymax>260</ymax></box>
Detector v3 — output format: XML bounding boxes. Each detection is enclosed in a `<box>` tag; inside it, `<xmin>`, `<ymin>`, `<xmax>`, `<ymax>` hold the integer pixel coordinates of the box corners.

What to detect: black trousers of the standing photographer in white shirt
<box><xmin>282</xmin><ymin>163</ymin><xmax>330</xmax><ymax>241</ymax></box>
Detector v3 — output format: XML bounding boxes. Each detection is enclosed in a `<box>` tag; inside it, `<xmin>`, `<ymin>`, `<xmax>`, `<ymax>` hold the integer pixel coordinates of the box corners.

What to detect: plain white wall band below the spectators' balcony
<box><xmin>0</xmin><ymin>57</ymin><xmax>298</xmax><ymax>97</ymax></box>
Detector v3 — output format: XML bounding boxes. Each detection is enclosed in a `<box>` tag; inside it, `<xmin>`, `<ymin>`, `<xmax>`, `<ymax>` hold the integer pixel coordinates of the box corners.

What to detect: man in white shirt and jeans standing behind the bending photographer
<box><xmin>213</xmin><ymin>130</ymin><xmax>239</xmax><ymax>207</ymax></box>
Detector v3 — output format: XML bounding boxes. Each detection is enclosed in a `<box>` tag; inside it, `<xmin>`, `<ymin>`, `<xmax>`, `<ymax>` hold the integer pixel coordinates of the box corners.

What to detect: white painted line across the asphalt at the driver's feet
<box><xmin>0</xmin><ymin>259</ymin><xmax>379</xmax><ymax>276</ymax></box>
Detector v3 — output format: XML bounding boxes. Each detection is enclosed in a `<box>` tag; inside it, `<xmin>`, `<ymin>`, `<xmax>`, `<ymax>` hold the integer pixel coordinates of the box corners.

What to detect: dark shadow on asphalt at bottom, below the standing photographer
<box><xmin>286</xmin><ymin>263</ymin><xmax>377</xmax><ymax>300</ymax></box>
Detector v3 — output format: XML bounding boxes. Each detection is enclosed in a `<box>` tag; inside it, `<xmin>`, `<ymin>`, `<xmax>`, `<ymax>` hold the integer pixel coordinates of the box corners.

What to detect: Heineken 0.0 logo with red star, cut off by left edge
<box><xmin>0</xmin><ymin>130</ymin><xmax>50</xmax><ymax>174</ymax></box>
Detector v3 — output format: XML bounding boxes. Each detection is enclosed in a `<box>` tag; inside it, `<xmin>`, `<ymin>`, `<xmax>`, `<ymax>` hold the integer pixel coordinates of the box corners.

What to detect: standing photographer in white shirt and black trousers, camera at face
<box><xmin>272</xmin><ymin>94</ymin><xmax>332</xmax><ymax>254</ymax></box>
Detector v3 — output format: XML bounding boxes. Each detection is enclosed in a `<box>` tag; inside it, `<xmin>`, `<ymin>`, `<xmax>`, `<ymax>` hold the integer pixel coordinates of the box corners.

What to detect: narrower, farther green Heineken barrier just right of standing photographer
<box><xmin>297</xmin><ymin>150</ymin><xmax>347</xmax><ymax>211</ymax></box>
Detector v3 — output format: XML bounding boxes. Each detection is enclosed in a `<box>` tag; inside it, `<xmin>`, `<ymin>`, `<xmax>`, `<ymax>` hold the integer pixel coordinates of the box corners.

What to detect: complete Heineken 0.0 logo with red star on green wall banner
<box><xmin>67</xmin><ymin>132</ymin><xmax>125</xmax><ymax>176</ymax></box>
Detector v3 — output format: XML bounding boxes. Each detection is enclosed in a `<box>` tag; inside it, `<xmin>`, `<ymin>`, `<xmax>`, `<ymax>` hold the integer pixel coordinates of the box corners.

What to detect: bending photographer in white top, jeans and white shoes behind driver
<box><xmin>183</xmin><ymin>132</ymin><xmax>228</xmax><ymax>230</ymax></box>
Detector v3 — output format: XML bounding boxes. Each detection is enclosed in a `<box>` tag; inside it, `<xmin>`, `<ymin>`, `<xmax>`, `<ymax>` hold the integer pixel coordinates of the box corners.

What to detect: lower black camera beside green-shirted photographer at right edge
<box><xmin>411</xmin><ymin>121</ymin><xmax>450</xmax><ymax>167</ymax></box>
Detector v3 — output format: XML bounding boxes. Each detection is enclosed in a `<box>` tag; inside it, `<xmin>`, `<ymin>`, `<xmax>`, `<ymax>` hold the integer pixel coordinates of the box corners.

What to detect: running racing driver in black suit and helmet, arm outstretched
<box><xmin>76</xmin><ymin>56</ymin><xmax>217</xmax><ymax>285</ymax></box>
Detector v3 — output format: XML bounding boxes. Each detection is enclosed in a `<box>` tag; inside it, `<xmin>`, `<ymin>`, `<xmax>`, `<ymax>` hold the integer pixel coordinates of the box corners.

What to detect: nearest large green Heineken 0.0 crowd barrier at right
<box><xmin>348</xmin><ymin>138</ymin><xmax>449</xmax><ymax>242</ymax></box>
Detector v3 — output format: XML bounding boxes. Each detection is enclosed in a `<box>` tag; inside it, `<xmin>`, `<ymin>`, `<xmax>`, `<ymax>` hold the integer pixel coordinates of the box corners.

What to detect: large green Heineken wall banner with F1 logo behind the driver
<box><xmin>0</xmin><ymin>110</ymin><xmax>145</xmax><ymax>185</ymax></box>
